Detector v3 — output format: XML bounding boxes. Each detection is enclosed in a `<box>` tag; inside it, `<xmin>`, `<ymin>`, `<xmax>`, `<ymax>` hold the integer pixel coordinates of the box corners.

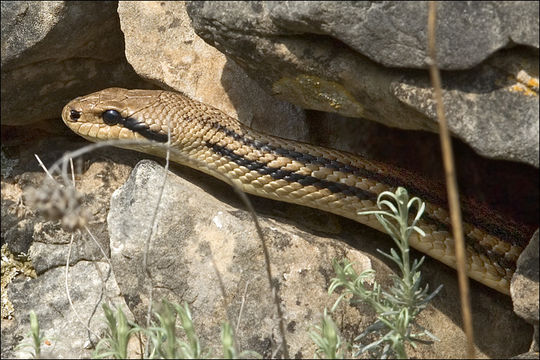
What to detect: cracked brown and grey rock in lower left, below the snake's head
<box><xmin>1</xmin><ymin>134</ymin><xmax>144</xmax><ymax>358</ymax></box>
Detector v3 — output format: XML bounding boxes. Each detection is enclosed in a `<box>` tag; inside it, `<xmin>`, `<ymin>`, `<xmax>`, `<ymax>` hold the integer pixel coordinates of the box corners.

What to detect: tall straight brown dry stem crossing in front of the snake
<box><xmin>427</xmin><ymin>1</ymin><xmax>475</xmax><ymax>358</ymax></box>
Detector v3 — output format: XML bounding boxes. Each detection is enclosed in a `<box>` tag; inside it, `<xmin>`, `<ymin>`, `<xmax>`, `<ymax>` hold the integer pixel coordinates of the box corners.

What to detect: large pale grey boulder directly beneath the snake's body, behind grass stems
<box><xmin>108</xmin><ymin>161</ymin><xmax>370</xmax><ymax>357</ymax></box>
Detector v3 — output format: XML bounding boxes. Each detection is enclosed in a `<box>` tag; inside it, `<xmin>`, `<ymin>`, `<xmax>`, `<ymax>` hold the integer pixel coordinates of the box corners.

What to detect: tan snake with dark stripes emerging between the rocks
<box><xmin>62</xmin><ymin>88</ymin><xmax>530</xmax><ymax>294</ymax></box>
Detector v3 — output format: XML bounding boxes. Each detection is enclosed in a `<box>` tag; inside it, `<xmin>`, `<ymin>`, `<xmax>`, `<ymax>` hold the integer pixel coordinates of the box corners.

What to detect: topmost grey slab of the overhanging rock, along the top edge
<box><xmin>188</xmin><ymin>1</ymin><xmax>539</xmax><ymax>70</ymax></box>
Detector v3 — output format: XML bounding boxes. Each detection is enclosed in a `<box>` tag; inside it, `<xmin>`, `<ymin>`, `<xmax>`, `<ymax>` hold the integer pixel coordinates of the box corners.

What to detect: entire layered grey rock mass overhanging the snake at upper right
<box><xmin>187</xmin><ymin>2</ymin><xmax>539</xmax><ymax>167</ymax></box>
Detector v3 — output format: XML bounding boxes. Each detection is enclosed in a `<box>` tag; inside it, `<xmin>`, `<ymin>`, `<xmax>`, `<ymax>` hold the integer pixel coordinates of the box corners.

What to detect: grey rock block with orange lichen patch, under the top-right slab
<box><xmin>391</xmin><ymin>46</ymin><xmax>540</xmax><ymax>167</ymax></box>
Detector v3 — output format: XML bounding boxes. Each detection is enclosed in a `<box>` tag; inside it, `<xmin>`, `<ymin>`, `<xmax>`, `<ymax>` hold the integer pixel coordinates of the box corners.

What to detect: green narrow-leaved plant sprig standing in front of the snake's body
<box><xmin>319</xmin><ymin>187</ymin><xmax>442</xmax><ymax>358</ymax></box>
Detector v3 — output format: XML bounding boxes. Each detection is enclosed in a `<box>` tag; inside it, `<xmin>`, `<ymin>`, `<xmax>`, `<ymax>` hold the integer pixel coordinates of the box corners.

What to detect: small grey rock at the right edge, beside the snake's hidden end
<box><xmin>510</xmin><ymin>230</ymin><xmax>540</xmax><ymax>352</ymax></box>
